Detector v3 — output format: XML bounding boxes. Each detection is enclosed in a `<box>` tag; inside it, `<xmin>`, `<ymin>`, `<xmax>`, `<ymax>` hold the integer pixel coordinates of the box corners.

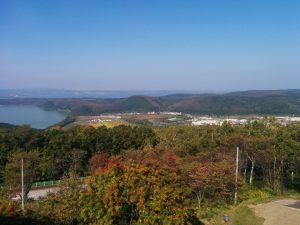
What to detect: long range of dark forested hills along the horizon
<box><xmin>0</xmin><ymin>90</ymin><xmax>300</xmax><ymax>115</ymax></box>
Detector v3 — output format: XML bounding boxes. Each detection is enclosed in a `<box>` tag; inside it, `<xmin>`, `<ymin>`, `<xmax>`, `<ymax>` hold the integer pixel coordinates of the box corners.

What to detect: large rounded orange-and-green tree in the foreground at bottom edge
<box><xmin>81</xmin><ymin>163</ymin><xmax>194</xmax><ymax>225</ymax></box>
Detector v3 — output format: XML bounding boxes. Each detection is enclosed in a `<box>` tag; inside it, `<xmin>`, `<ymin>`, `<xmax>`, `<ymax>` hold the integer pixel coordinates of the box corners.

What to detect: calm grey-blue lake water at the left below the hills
<box><xmin>0</xmin><ymin>106</ymin><xmax>66</xmax><ymax>129</ymax></box>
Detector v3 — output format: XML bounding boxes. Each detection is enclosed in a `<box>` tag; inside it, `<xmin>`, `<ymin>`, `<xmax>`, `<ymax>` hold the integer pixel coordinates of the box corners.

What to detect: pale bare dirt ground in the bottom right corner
<box><xmin>249</xmin><ymin>199</ymin><xmax>300</xmax><ymax>225</ymax></box>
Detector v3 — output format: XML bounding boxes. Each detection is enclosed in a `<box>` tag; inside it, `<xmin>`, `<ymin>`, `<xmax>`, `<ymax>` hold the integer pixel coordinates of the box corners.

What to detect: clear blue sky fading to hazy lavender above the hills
<box><xmin>0</xmin><ymin>0</ymin><xmax>300</xmax><ymax>91</ymax></box>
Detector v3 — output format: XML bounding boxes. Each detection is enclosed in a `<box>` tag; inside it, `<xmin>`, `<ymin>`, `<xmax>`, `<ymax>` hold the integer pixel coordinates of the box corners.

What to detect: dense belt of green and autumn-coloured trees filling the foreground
<box><xmin>0</xmin><ymin>118</ymin><xmax>300</xmax><ymax>225</ymax></box>
